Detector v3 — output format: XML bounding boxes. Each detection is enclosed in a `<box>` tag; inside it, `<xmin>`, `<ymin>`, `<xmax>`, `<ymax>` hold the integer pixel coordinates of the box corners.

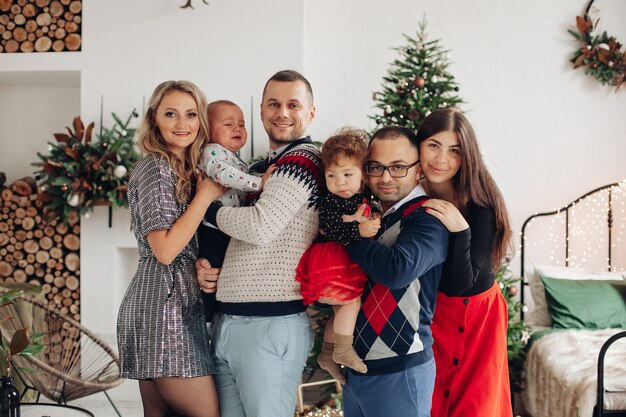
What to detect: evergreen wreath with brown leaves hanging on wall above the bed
<box><xmin>568</xmin><ymin>0</ymin><xmax>626</xmax><ymax>90</ymax></box>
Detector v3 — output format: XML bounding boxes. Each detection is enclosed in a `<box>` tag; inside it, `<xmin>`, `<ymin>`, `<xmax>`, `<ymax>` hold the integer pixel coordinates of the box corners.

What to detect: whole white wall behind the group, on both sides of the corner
<box><xmin>0</xmin><ymin>0</ymin><xmax>626</xmax><ymax>333</ymax></box>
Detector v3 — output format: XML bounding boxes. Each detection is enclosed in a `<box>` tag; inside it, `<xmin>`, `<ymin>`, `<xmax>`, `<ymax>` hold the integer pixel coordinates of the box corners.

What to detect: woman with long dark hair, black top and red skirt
<box><xmin>417</xmin><ymin>109</ymin><xmax>512</xmax><ymax>417</ymax></box>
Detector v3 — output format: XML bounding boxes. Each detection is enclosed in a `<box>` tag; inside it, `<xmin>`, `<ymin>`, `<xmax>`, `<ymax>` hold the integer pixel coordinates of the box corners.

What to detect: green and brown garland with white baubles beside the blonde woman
<box><xmin>31</xmin><ymin>110</ymin><xmax>140</xmax><ymax>220</ymax></box>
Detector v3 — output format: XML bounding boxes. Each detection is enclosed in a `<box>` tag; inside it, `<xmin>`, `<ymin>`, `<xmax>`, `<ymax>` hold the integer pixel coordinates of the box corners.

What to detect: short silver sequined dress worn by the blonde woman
<box><xmin>117</xmin><ymin>156</ymin><xmax>214</xmax><ymax>379</ymax></box>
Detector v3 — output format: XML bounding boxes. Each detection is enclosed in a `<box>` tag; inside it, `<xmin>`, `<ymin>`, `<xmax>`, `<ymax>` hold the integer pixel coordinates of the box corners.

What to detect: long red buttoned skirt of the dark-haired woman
<box><xmin>431</xmin><ymin>282</ymin><xmax>513</xmax><ymax>417</ymax></box>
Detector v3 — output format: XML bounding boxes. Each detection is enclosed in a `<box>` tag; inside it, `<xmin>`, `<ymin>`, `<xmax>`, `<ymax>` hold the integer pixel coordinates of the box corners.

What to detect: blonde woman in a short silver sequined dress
<box><xmin>117</xmin><ymin>81</ymin><xmax>224</xmax><ymax>417</ymax></box>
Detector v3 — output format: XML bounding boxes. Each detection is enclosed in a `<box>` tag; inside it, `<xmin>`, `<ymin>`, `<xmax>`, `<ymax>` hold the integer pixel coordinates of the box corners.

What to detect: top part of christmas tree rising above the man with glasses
<box><xmin>370</xmin><ymin>20</ymin><xmax>463</xmax><ymax>131</ymax></box>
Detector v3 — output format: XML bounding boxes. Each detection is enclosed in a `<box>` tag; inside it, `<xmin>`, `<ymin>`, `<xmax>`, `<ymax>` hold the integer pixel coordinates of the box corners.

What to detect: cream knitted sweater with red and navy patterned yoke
<box><xmin>205</xmin><ymin>138</ymin><xmax>323</xmax><ymax>316</ymax></box>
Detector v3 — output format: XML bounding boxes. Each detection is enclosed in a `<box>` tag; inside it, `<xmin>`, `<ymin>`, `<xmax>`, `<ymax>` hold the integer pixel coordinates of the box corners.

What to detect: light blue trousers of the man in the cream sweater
<box><xmin>211</xmin><ymin>312</ymin><xmax>313</xmax><ymax>417</ymax></box>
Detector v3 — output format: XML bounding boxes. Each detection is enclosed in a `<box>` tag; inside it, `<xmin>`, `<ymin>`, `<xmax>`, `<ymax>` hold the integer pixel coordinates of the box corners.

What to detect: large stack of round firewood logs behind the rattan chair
<box><xmin>0</xmin><ymin>177</ymin><xmax>80</xmax><ymax>320</ymax></box>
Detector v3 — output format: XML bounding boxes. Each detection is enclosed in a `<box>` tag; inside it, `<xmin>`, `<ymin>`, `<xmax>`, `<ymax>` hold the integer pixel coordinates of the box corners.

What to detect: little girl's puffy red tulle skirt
<box><xmin>296</xmin><ymin>242</ymin><xmax>367</xmax><ymax>304</ymax></box>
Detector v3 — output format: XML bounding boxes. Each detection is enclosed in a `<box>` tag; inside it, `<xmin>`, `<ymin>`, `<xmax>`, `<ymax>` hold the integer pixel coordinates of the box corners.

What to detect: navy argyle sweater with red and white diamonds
<box><xmin>346</xmin><ymin>196</ymin><xmax>448</xmax><ymax>375</ymax></box>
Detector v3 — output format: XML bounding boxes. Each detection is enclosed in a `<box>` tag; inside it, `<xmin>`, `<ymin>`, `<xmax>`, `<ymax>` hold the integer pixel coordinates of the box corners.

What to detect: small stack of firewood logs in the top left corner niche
<box><xmin>0</xmin><ymin>0</ymin><xmax>82</xmax><ymax>52</ymax></box>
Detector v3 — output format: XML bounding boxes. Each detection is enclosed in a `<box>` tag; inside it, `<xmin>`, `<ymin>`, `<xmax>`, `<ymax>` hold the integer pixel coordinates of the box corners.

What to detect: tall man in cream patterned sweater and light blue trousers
<box><xmin>197</xmin><ymin>70</ymin><xmax>323</xmax><ymax>417</ymax></box>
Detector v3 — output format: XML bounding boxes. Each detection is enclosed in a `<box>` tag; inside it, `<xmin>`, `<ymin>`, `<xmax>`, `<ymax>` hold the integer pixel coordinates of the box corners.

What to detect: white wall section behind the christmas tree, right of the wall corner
<box><xmin>304</xmin><ymin>0</ymin><xmax>626</xmax><ymax>273</ymax></box>
